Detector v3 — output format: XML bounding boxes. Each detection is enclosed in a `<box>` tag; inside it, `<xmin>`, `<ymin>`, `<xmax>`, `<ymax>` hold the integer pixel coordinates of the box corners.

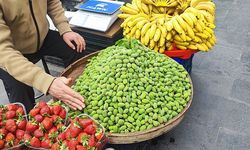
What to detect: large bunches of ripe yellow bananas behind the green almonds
<box><xmin>119</xmin><ymin>0</ymin><xmax>216</xmax><ymax>53</ymax></box>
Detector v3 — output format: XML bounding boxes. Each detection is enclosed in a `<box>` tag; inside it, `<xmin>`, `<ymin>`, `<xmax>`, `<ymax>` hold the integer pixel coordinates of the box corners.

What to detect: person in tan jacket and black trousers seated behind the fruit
<box><xmin>0</xmin><ymin>0</ymin><xmax>87</xmax><ymax>110</ymax></box>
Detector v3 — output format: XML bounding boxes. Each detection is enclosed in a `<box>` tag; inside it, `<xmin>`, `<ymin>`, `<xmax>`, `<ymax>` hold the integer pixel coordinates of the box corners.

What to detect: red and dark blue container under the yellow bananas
<box><xmin>164</xmin><ymin>45</ymin><xmax>198</xmax><ymax>73</ymax></box>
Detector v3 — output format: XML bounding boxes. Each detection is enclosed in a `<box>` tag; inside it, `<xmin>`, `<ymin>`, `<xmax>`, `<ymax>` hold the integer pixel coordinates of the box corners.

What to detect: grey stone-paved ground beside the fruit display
<box><xmin>0</xmin><ymin>0</ymin><xmax>250</xmax><ymax>150</ymax></box>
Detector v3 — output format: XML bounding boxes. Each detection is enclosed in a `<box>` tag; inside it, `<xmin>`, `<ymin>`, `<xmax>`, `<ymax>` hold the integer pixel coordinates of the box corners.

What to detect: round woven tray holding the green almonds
<box><xmin>61</xmin><ymin>52</ymin><xmax>193</xmax><ymax>144</ymax></box>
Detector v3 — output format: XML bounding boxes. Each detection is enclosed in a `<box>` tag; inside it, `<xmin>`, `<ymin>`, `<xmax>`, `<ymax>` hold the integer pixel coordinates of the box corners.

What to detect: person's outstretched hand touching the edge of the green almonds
<box><xmin>48</xmin><ymin>77</ymin><xmax>85</xmax><ymax>110</ymax></box>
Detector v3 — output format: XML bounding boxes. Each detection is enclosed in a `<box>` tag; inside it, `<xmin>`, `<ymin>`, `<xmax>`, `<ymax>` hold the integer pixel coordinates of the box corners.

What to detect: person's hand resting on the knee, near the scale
<box><xmin>63</xmin><ymin>32</ymin><xmax>86</xmax><ymax>53</ymax></box>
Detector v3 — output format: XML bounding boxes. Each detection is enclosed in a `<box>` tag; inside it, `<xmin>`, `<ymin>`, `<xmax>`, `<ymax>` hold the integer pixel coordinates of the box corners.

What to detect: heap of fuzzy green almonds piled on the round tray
<box><xmin>72</xmin><ymin>39</ymin><xmax>192</xmax><ymax>133</ymax></box>
